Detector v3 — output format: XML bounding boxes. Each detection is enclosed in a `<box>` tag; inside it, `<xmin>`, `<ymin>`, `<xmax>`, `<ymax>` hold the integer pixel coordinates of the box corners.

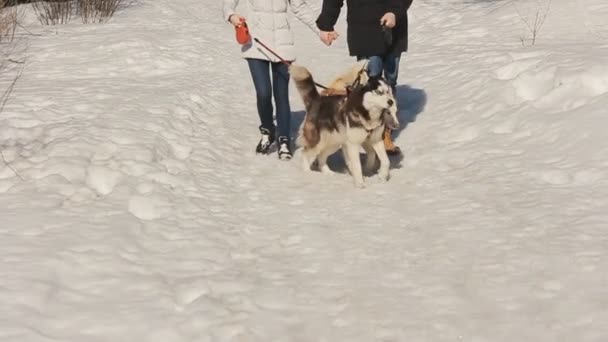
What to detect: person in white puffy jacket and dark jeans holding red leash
<box><xmin>223</xmin><ymin>0</ymin><xmax>320</xmax><ymax>160</ymax></box>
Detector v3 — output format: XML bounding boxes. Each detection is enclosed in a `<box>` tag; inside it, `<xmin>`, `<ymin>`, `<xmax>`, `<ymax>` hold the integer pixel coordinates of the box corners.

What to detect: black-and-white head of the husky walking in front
<box><xmin>352</xmin><ymin>76</ymin><xmax>399</xmax><ymax>129</ymax></box>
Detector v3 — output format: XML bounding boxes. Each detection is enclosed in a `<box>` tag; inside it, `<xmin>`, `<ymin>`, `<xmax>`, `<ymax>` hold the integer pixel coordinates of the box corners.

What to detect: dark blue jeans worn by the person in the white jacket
<box><xmin>246</xmin><ymin>58</ymin><xmax>291</xmax><ymax>138</ymax></box>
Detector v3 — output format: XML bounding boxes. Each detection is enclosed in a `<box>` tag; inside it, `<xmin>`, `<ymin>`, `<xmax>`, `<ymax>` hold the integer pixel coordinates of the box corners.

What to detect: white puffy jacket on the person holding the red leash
<box><xmin>223</xmin><ymin>0</ymin><xmax>320</xmax><ymax>62</ymax></box>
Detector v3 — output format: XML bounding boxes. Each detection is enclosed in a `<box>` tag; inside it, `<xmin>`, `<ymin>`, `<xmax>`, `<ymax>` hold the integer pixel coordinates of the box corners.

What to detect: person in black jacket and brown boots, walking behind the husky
<box><xmin>316</xmin><ymin>0</ymin><xmax>413</xmax><ymax>154</ymax></box>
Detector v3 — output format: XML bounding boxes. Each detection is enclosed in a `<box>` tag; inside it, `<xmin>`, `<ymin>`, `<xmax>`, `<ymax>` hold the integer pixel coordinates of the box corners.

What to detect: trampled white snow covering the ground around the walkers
<box><xmin>0</xmin><ymin>0</ymin><xmax>608</xmax><ymax>342</ymax></box>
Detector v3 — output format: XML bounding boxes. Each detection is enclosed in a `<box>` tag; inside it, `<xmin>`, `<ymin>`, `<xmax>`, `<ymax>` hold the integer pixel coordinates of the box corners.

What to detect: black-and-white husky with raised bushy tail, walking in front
<box><xmin>289</xmin><ymin>64</ymin><xmax>399</xmax><ymax>188</ymax></box>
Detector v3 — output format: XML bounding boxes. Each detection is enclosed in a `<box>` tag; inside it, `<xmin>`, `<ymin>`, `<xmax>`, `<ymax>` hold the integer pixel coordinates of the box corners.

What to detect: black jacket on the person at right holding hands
<box><xmin>317</xmin><ymin>0</ymin><xmax>412</xmax><ymax>57</ymax></box>
